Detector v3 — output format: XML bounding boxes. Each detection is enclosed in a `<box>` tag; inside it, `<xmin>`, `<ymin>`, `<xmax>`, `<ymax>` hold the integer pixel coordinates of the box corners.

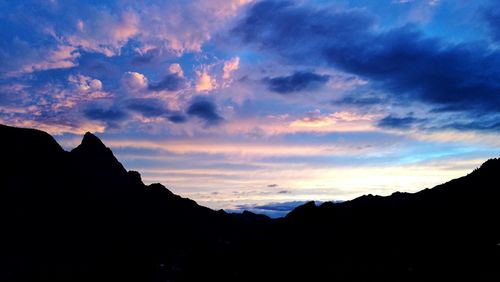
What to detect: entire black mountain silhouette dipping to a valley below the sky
<box><xmin>0</xmin><ymin>126</ymin><xmax>500</xmax><ymax>281</ymax></box>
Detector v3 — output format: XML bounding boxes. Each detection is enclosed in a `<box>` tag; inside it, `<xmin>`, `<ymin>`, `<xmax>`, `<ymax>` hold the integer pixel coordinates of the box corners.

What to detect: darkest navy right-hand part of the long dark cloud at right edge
<box><xmin>325</xmin><ymin>27</ymin><xmax>500</xmax><ymax>114</ymax></box>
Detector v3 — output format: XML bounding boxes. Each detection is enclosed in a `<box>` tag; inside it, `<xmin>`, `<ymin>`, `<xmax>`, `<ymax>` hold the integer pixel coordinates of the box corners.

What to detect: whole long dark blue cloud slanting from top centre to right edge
<box><xmin>233</xmin><ymin>1</ymin><xmax>500</xmax><ymax>119</ymax></box>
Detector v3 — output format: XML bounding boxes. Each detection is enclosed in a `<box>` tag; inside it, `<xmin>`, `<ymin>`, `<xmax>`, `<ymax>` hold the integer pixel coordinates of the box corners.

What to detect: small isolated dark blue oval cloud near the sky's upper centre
<box><xmin>263</xmin><ymin>72</ymin><xmax>330</xmax><ymax>94</ymax></box>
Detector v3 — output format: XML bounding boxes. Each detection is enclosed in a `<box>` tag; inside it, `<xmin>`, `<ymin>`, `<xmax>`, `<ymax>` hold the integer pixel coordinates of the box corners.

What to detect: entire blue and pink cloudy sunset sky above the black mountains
<box><xmin>0</xmin><ymin>0</ymin><xmax>500</xmax><ymax>215</ymax></box>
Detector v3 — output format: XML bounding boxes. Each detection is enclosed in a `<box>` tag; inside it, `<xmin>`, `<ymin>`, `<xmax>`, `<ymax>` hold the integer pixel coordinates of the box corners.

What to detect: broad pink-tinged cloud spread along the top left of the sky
<box><xmin>0</xmin><ymin>0</ymin><xmax>253</xmax><ymax>76</ymax></box>
